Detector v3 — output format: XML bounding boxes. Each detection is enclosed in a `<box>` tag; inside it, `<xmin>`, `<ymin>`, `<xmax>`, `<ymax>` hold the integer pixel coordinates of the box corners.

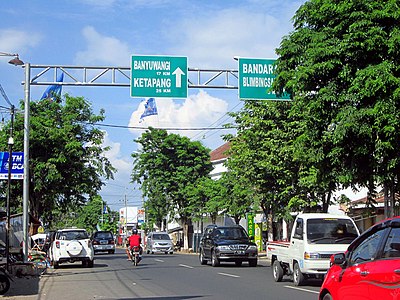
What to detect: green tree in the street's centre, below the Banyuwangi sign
<box><xmin>132</xmin><ymin>127</ymin><xmax>212</xmax><ymax>248</ymax></box>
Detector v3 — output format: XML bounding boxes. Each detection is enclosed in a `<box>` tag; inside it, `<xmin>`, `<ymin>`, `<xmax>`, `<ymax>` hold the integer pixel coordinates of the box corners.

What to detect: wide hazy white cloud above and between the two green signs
<box><xmin>165</xmin><ymin>7</ymin><xmax>291</xmax><ymax>68</ymax></box>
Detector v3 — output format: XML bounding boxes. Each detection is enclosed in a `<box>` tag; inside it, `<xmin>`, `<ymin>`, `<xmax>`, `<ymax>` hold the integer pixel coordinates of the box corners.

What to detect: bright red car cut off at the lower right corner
<box><xmin>319</xmin><ymin>217</ymin><xmax>400</xmax><ymax>300</ymax></box>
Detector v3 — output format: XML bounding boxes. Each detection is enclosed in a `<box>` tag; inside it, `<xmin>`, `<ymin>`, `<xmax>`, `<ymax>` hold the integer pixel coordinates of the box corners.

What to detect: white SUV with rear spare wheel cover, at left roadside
<box><xmin>49</xmin><ymin>228</ymin><xmax>94</xmax><ymax>269</ymax></box>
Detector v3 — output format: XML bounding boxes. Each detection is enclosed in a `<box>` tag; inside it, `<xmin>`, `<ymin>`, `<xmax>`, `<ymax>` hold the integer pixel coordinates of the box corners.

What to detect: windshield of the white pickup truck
<box><xmin>307</xmin><ymin>218</ymin><xmax>358</xmax><ymax>244</ymax></box>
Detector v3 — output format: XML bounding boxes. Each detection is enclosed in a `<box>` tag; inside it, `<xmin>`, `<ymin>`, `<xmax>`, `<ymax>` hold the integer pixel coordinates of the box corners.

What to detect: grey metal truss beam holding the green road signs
<box><xmin>26</xmin><ymin>65</ymin><xmax>238</xmax><ymax>89</ymax></box>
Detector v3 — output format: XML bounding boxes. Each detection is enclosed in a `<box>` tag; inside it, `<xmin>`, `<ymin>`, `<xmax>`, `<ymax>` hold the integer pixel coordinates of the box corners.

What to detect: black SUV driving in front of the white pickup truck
<box><xmin>199</xmin><ymin>225</ymin><xmax>258</xmax><ymax>267</ymax></box>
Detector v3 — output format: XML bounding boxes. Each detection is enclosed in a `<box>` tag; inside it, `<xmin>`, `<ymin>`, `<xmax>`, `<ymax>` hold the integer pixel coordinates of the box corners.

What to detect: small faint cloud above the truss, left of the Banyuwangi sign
<box><xmin>75</xmin><ymin>26</ymin><xmax>131</xmax><ymax>66</ymax></box>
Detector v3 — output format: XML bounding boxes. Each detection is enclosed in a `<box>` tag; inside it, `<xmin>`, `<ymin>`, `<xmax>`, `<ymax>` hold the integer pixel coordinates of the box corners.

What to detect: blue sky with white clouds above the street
<box><xmin>0</xmin><ymin>0</ymin><xmax>310</xmax><ymax>210</ymax></box>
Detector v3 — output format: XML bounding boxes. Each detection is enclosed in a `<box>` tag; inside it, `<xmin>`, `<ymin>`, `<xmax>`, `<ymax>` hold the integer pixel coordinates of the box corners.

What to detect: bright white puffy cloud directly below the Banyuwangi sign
<box><xmin>129</xmin><ymin>90</ymin><xmax>228</xmax><ymax>137</ymax></box>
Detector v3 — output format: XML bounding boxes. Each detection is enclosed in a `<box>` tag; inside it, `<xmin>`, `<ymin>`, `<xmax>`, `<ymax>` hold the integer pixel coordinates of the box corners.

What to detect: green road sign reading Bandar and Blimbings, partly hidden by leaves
<box><xmin>238</xmin><ymin>58</ymin><xmax>290</xmax><ymax>100</ymax></box>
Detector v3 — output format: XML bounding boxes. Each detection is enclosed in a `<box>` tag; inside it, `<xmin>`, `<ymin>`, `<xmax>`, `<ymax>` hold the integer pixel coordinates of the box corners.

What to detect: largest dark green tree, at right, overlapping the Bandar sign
<box><xmin>274</xmin><ymin>0</ymin><xmax>400</xmax><ymax>216</ymax></box>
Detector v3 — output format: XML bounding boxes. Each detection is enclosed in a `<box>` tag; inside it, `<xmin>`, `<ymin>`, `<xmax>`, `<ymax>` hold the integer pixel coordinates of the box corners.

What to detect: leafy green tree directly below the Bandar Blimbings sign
<box><xmin>226</xmin><ymin>101</ymin><xmax>306</xmax><ymax>217</ymax></box>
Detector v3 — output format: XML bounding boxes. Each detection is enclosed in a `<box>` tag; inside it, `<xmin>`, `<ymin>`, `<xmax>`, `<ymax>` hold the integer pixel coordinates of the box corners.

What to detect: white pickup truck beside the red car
<box><xmin>267</xmin><ymin>213</ymin><xmax>360</xmax><ymax>286</ymax></box>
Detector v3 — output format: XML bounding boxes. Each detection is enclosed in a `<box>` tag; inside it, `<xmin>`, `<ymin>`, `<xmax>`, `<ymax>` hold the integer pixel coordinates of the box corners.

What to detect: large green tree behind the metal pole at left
<box><xmin>0</xmin><ymin>94</ymin><xmax>115</xmax><ymax>223</ymax></box>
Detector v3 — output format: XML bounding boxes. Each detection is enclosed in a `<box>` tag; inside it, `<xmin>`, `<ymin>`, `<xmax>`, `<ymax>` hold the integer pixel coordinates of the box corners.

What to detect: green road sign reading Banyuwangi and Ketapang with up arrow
<box><xmin>131</xmin><ymin>55</ymin><xmax>188</xmax><ymax>98</ymax></box>
